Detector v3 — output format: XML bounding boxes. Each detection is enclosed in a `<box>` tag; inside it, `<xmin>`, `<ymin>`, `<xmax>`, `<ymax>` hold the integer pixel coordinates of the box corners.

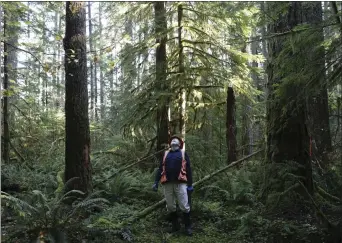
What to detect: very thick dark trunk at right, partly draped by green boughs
<box><xmin>264</xmin><ymin>2</ymin><xmax>313</xmax><ymax>196</ymax></box>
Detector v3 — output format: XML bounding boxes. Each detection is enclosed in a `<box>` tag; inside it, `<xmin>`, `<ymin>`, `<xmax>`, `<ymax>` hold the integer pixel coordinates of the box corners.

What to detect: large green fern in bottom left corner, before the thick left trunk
<box><xmin>1</xmin><ymin>186</ymin><xmax>108</xmax><ymax>242</ymax></box>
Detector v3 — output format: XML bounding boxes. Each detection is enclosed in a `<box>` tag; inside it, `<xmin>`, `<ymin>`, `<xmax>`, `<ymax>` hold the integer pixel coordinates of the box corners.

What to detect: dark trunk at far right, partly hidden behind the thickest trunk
<box><xmin>305</xmin><ymin>2</ymin><xmax>332</xmax><ymax>164</ymax></box>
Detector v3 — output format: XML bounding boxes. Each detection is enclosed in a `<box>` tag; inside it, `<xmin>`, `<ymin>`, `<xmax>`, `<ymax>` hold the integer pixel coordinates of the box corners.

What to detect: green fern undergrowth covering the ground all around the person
<box><xmin>1</xmin><ymin>145</ymin><xmax>342</xmax><ymax>243</ymax></box>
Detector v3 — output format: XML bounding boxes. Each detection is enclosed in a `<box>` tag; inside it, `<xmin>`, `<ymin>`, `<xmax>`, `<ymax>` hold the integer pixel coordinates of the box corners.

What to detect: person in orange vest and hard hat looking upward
<box><xmin>153</xmin><ymin>136</ymin><xmax>193</xmax><ymax>236</ymax></box>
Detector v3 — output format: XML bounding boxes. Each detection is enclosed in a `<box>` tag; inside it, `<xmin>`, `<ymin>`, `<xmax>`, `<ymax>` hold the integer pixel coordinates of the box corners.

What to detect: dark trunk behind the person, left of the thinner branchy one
<box><xmin>154</xmin><ymin>2</ymin><xmax>169</xmax><ymax>159</ymax></box>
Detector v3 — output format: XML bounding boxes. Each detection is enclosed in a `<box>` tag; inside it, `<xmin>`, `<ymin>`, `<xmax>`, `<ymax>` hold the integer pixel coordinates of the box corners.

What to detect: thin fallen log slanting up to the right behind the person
<box><xmin>122</xmin><ymin>149</ymin><xmax>263</xmax><ymax>225</ymax></box>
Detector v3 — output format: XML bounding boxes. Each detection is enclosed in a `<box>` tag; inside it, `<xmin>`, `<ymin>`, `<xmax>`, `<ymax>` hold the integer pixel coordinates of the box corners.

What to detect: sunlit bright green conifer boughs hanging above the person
<box><xmin>115</xmin><ymin>3</ymin><xmax>260</xmax><ymax>138</ymax></box>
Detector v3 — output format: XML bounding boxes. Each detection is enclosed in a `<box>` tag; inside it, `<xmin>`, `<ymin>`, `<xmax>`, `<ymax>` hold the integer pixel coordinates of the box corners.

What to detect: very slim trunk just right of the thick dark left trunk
<box><xmin>88</xmin><ymin>2</ymin><xmax>95</xmax><ymax>119</ymax></box>
